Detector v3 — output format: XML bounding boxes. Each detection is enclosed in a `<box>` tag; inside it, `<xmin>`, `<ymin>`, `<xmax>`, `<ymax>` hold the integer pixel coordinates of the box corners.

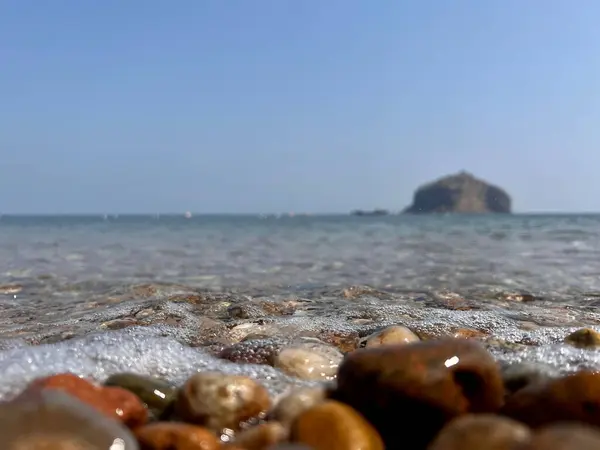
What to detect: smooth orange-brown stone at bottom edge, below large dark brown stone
<box><xmin>291</xmin><ymin>400</ymin><xmax>384</xmax><ymax>450</ymax></box>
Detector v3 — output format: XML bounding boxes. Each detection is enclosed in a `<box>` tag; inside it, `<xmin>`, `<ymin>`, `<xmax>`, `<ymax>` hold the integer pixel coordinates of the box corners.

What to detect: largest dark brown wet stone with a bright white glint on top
<box><xmin>333</xmin><ymin>339</ymin><xmax>504</xmax><ymax>448</ymax></box>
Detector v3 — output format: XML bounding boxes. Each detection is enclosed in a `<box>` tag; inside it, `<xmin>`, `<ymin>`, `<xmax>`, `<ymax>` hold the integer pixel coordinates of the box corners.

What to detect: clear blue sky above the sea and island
<box><xmin>0</xmin><ymin>0</ymin><xmax>600</xmax><ymax>213</ymax></box>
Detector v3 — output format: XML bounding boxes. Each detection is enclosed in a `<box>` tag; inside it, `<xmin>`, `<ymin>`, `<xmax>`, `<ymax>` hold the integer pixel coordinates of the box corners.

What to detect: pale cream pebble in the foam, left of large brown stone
<box><xmin>274</xmin><ymin>338</ymin><xmax>344</xmax><ymax>380</ymax></box>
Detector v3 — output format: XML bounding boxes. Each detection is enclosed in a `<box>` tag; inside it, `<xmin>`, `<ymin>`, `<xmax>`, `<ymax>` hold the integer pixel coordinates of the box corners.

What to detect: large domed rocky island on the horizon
<box><xmin>403</xmin><ymin>171</ymin><xmax>511</xmax><ymax>214</ymax></box>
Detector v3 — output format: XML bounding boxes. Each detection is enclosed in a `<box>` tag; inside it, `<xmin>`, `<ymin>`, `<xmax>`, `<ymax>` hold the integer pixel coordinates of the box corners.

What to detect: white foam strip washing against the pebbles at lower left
<box><xmin>0</xmin><ymin>328</ymin><xmax>309</xmax><ymax>400</ymax></box>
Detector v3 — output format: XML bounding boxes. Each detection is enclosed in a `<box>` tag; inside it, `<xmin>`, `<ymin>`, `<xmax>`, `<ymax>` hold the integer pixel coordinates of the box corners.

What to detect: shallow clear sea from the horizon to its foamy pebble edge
<box><xmin>0</xmin><ymin>214</ymin><xmax>600</xmax><ymax>399</ymax></box>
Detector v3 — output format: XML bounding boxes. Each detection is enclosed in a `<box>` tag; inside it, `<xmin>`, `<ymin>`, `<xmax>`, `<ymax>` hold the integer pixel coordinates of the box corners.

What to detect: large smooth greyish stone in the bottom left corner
<box><xmin>0</xmin><ymin>389</ymin><xmax>138</xmax><ymax>450</ymax></box>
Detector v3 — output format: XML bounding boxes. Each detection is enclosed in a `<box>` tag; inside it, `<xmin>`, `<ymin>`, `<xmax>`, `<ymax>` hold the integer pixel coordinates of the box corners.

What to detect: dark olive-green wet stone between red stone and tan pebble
<box><xmin>104</xmin><ymin>373</ymin><xmax>177</xmax><ymax>418</ymax></box>
